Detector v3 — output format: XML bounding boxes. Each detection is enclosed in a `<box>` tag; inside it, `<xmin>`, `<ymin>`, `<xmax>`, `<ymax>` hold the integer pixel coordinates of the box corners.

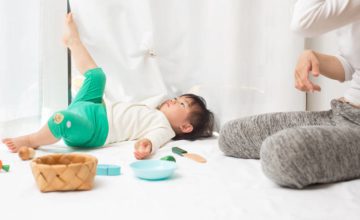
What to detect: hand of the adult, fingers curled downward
<box><xmin>295</xmin><ymin>50</ymin><xmax>321</xmax><ymax>92</ymax></box>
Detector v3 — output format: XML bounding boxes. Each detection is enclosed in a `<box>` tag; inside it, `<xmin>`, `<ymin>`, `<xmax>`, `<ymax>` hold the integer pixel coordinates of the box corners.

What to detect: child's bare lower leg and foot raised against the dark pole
<box><xmin>63</xmin><ymin>13</ymin><xmax>97</xmax><ymax>74</ymax></box>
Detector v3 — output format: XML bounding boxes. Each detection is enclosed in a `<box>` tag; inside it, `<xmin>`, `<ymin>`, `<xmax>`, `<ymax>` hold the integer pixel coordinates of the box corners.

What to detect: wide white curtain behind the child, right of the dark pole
<box><xmin>71</xmin><ymin>0</ymin><xmax>305</xmax><ymax>129</ymax></box>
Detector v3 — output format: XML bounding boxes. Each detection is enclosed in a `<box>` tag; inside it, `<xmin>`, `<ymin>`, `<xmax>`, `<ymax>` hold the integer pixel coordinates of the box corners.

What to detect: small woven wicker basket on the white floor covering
<box><xmin>31</xmin><ymin>154</ymin><xmax>97</xmax><ymax>192</ymax></box>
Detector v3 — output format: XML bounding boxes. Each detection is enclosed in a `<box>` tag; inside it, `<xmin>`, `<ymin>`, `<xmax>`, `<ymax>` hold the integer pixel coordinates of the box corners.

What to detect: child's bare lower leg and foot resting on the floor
<box><xmin>2</xmin><ymin>124</ymin><xmax>59</xmax><ymax>153</ymax></box>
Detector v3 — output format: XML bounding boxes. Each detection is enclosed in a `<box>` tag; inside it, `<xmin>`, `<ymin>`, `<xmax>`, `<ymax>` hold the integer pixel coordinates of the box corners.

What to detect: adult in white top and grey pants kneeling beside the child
<box><xmin>219</xmin><ymin>0</ymin><xmax>360</xmax><ymax>188</ymax></box>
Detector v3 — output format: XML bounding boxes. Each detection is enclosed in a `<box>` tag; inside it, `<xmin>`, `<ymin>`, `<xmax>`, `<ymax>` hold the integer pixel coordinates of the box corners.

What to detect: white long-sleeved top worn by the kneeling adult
<box><xmin>291</xmin><ymin>0</ymin><xmax>360</xmax><ymax>105</ymax></box>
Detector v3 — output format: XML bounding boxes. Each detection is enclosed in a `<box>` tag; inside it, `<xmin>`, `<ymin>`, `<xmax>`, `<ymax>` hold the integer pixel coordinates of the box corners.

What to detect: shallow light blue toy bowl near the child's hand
<box><xmin>130</xmin><ymin>160</ymin><xmax>176</xmax><ymax>180</ymax></box>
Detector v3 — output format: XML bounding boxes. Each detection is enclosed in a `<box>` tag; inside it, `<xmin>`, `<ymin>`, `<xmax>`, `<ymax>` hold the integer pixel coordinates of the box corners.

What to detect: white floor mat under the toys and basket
<box><xmin>0</xmin><ymin>139</ymin><xmax>360</xmax><ymax>220</ymax></box>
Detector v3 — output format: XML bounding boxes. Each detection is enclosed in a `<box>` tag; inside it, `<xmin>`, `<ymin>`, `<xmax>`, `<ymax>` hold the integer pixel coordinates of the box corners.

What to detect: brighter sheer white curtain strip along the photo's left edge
<box><xmin>0</xmin><ymin>0</ymin><xmax>41</xmax><ymax>137</ymax></box>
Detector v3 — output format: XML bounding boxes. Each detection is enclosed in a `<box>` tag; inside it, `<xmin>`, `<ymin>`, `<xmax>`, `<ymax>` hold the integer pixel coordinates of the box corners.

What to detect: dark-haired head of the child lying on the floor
<box><xmin>159</xmin><ymin>94</ymin><xmax>214</xmax><ymax>140</ymax></box>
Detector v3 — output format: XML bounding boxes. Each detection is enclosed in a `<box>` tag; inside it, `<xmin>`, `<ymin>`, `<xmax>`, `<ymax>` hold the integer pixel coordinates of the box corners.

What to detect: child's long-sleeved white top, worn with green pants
<box><xmin>105</xmin><ymin>100</ymin><xmax>175</xmax><ymax>153</ymax></box>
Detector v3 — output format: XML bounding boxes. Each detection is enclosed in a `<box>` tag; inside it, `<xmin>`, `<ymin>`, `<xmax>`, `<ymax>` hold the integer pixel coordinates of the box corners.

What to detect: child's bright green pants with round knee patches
<box><xmin>48</xmin><ymin>68</ymin><xmax>109</xmax><ymax>148</ymax></box>
